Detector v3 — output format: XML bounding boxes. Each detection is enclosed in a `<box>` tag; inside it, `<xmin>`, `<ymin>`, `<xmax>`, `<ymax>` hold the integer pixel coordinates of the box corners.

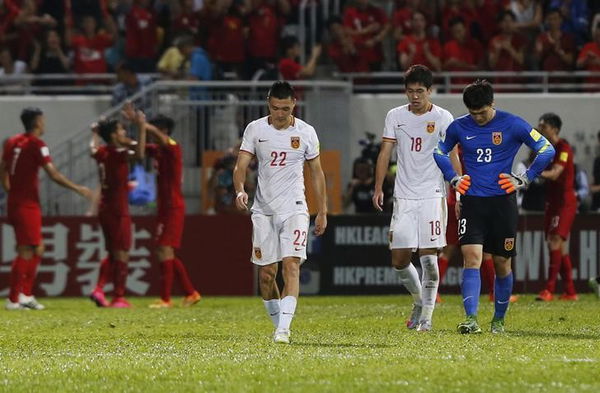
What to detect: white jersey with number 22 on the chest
<box><xmin>240</xmin><ymin>116</ymin><xmax>319</xmax><ymax>215</ymax></box>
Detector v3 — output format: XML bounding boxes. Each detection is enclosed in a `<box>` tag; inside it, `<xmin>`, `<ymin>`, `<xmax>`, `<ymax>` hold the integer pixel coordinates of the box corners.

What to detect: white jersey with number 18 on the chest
<box><xmin>383</xmin><ymin>104</ymin><xmax>454</xmax><ymax>199</ymax></box>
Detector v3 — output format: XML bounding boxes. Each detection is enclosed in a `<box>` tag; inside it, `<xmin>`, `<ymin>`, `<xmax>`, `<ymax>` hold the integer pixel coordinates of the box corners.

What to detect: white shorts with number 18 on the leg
<box><xmin>389</xmin><ymin>198</ymin><xmax>448</xmax><ymax>250</ymax></box>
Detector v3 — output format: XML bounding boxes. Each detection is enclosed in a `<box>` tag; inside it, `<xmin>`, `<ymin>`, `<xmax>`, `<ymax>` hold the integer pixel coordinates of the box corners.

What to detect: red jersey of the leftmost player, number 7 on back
<box><xmin>2</xmin><ymin>133</ymin><xmax>52</xmax><ymax>206</ymax></box>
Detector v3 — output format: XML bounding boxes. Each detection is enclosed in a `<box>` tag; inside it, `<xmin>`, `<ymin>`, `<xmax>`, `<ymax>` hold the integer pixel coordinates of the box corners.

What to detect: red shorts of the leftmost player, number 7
<box><xmin>8</xmin><ymin>205</ymin><xmax>42</xmax><ymax>246</ymax></box>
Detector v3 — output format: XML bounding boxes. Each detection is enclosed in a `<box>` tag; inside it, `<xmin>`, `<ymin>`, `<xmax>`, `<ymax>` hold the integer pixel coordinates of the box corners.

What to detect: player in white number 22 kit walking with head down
<box><xmin>233</xmin><ymin>81</ymin><xmax>327</xmax><ymax>343</ymax></box>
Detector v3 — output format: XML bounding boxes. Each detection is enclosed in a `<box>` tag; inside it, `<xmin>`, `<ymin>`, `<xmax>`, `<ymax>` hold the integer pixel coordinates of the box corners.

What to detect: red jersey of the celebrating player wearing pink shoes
<box><xmin>93</xmin><ymin>146</ymin><xmax>130</xmax><ymax>216</ymax></box>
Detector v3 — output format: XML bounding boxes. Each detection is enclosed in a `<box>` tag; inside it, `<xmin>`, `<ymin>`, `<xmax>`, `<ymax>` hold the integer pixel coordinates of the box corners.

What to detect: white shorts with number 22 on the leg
<box><xmin>252</xmin><ymin>212</ymin><xmax>310</xmax><ymax>266</ymax></box>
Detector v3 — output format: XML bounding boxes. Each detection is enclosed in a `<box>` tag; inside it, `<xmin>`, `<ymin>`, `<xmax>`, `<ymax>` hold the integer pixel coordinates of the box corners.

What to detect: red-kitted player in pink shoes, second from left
<box><xmin>90</xmin><ymin>120</ymin><xmax>135</xmax><ymax>308</ymax></box>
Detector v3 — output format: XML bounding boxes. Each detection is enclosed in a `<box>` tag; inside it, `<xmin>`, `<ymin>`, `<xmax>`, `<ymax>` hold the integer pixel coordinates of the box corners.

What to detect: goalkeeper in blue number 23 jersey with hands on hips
<box><xmin>434</xmin><ymin>80</ymin><xmax>554</xmax><ymax>334</ymax></box>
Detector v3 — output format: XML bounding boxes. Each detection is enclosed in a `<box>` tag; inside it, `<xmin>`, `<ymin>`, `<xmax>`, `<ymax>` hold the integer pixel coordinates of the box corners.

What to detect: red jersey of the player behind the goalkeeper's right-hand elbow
<box><xmin>546</xmin><ymin>139</ymin><xmax>577</xmax><ymax>205</ymax></box>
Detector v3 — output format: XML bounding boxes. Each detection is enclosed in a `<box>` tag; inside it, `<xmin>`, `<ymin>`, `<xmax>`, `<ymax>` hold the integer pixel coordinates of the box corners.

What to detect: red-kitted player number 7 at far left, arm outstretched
<box><xmin>0</xmin><ymin>108</ymin><xmax>91</xmax><ymax>310</ymax></box>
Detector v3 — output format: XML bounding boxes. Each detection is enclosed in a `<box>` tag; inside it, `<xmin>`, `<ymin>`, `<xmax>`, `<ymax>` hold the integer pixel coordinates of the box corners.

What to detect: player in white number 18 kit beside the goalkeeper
<box><xmin>373</xmin><ymin>65</ymin><xmax>453</xmax><ymax>331</ymax></box>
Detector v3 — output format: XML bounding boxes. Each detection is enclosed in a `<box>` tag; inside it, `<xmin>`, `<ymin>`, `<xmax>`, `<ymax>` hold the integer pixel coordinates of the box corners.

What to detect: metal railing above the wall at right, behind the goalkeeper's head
<box><xmin>334</xmin><ymin>71</ymin><xmax>600</xmax><ymax>93</ymax></box>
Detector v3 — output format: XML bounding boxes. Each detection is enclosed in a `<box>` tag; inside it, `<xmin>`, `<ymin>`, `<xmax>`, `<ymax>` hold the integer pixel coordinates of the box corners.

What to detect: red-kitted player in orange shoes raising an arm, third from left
<box><xmin>124</xmin><ymin>105</ymin><xmax>201</xmax><ymax>308</ymax></box>
